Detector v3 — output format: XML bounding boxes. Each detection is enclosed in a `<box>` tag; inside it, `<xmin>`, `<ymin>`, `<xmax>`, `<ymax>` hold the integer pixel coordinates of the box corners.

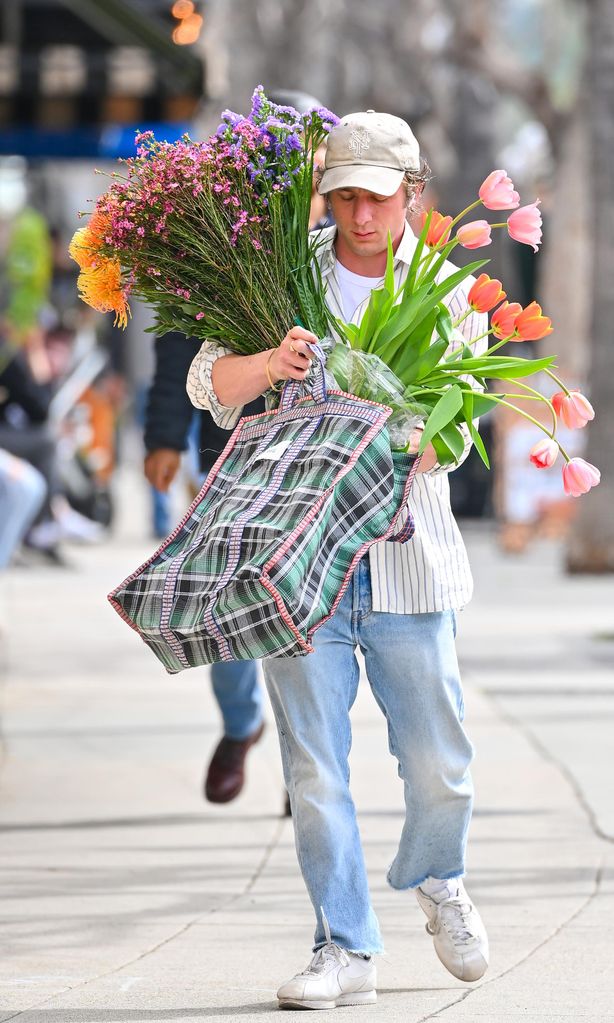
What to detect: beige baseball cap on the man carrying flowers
<box><xmin>318</xmin><ymin>110</ymin><xmax>420</xmax><ymax>195</ymax></box>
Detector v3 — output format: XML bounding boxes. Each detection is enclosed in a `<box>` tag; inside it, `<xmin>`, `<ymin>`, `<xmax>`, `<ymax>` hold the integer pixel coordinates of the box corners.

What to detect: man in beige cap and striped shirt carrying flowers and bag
<box><xmin>187</xmin><ymin>110</ymin><xmax>488</xmax><ymax>1009</ymax></box>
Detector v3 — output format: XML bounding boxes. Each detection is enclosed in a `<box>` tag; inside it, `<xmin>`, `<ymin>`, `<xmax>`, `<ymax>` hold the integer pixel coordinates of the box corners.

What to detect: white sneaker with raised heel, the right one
<box><xmin>415</xmin><ymin>878</ymin><xmax>488</xmax><ymax>981</ymax></box>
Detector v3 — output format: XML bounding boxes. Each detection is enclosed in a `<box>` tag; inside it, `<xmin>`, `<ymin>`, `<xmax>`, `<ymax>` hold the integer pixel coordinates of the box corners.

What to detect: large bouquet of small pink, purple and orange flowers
<box><xmin>70</xmin><ymin>86</ymin><xmax>337</xmax><ymax>343</ymax></box>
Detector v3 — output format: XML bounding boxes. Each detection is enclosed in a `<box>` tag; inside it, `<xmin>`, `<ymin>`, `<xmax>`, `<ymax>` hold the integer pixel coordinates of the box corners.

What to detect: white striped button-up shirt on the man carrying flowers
<box><xmin>187</xmin><ymin>225</ymin><xmax>487</xmax><ymax>615</ymax></box>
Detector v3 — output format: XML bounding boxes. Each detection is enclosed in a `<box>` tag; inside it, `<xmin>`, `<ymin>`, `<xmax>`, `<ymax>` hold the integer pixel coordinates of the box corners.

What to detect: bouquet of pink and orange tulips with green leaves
<box><xmin>327</xmin><ymin>170</ymin><xmax>600</xmax><ymax>497</ymax></box>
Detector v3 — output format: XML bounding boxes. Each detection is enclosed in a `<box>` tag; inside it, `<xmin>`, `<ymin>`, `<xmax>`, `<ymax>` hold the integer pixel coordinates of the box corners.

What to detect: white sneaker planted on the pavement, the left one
<box><xmin>277</xmin><ymin>917</ymin><xmax>378</xmax><ymax>1009</ymax></box>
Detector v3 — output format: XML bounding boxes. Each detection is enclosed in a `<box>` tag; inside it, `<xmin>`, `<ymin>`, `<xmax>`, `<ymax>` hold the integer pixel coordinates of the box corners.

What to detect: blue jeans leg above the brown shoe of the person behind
<box><xmin>211</xmin><ymin>661</ymin><xmax>262</xmax><ymax>739</ymax></box>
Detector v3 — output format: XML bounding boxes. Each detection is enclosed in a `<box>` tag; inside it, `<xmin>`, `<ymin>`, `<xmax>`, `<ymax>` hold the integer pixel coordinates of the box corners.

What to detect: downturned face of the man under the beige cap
<box><xmin>331</xmin><ymin>184</ymin><xmax>407</xmax><ymax>262</ymax></box>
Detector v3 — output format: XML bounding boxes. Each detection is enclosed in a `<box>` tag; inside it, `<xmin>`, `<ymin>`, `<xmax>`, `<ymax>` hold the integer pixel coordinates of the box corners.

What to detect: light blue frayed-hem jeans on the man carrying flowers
<box><xmin>264</xmin><ymin>559</ymin><xmax>473</xmax><ymax>953</ymax></box>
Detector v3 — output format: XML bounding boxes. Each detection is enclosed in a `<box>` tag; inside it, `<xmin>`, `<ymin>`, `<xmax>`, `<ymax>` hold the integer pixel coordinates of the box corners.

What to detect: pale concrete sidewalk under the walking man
<box><xmin>0</xmin><ymin>468</ymin><xmax>614</xmax><ymax>1023</ymax></box>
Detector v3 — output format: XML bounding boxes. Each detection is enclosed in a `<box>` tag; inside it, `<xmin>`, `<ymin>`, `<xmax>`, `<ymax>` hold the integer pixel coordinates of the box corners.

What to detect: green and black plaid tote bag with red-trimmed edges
<box><xmin>108</xmin><ymin>365</ymin><xmax>418</xmax><ymax>673</ymax></box>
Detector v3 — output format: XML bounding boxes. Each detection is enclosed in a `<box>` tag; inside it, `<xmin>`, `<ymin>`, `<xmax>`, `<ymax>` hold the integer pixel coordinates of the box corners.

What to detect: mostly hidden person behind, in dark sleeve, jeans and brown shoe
<box><xmin>144</xmin><ymin>333</ymin><xmax>264</xmax><ymax>803</ymax></box>
